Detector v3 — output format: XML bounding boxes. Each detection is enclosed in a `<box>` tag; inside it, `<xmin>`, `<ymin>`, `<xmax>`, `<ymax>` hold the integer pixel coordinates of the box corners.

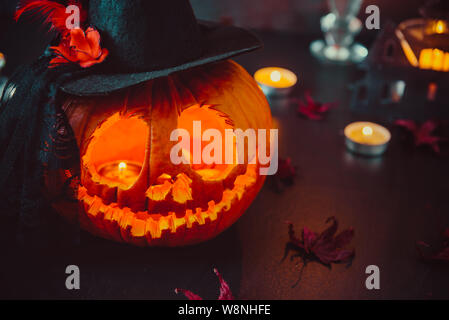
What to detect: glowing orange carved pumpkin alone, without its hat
<box><xmin>48</xmin><ymin>60</ymin><xmax>271</xmax><ymax>246</ymax></box>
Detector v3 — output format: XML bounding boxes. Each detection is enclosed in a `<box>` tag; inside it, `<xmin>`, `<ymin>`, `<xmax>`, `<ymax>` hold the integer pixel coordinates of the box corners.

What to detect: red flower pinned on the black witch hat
<box><xmin>50</xmin><ymin>27</ymin><xmax>109</xmax><ymax>68</ymax></box>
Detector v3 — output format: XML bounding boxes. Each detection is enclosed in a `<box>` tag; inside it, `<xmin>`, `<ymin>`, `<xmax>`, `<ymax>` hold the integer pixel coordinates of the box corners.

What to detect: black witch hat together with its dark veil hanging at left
<box><xmin>0</xmin><ymin>0</ymin><xmax>261</xmax><ymax>248</ymax></box>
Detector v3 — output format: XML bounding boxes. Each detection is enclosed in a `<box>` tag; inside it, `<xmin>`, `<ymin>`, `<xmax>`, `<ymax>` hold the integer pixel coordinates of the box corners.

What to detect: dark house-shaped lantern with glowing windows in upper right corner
<box><xmin>352</xmin><ymin>1</ymin><xmax>449</xmax><ymax>120</ymax></box>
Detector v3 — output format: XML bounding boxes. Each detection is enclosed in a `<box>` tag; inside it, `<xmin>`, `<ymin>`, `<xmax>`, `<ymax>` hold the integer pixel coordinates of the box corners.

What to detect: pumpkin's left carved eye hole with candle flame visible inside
<box><xmin>82</xmin><ymin>113</ymin><xmax>148</xmax><ymax>189</ymax></box>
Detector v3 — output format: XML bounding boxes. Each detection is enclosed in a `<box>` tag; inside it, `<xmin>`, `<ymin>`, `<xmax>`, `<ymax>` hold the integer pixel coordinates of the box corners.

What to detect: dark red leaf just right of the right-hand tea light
<box><xmin>395</xmin><ymin>119</ymin><xmax>445</xmax><ymax>153</ymax></box>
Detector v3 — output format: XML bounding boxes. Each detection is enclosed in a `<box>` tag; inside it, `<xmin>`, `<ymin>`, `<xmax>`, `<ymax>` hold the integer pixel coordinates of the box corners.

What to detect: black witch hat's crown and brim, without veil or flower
<box><xmin>62</xmin><ymin>0</ymin><xmax>261</xmax><ymax>95</ymax></box>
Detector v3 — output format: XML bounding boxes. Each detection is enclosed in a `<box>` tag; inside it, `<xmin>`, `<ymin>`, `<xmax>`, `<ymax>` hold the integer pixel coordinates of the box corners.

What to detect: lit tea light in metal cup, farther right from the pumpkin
<box><xmin>345</xmin><ymin>122</ymin><xmax>391</xmax><ymax>156</ymax></box>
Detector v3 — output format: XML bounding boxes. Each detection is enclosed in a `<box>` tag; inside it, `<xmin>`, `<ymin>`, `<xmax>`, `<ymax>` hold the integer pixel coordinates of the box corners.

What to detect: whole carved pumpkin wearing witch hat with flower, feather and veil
<box><xmin>0</xmin><ymin>0</ymin><xmax>271</xmax><ymax>246</ymax></box>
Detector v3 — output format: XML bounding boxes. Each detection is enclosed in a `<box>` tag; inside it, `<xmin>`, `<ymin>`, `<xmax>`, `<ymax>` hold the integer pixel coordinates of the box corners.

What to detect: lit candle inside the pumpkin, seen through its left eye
<box><xmin>98</xmin><ymin>161</ymin><xmax>142</xmax><ymax>186</ymax></box>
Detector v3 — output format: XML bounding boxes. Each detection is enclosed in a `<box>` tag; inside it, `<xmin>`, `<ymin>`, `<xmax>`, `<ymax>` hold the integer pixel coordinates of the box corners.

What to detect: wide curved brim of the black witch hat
<box><xmin>61</xmin><ymin>21</ymin><xmax>262</xmax><ymax>96</ymax></box>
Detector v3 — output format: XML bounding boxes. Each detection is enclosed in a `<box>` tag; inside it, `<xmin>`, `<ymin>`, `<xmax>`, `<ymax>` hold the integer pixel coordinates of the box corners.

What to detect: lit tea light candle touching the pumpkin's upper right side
<box><xmin>254</xmin><ymin>67</ymin><xmax>298</xmax><ymax>96</ymax></box>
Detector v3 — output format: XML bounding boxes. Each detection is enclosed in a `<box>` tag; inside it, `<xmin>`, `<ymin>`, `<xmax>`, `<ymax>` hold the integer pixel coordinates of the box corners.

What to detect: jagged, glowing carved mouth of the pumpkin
<box><xmin>78</xmin><ymin>165</ymin><xmax>257</xmax><ymax>246</ymax></box>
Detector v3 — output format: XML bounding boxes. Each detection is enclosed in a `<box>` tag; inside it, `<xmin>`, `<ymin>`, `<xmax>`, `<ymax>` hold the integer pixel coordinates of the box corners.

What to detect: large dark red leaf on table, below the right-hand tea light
<box><xmin>288</xmin><ymin>217</ymin><xmax>355</xmax><ymax>265</ymax></box>
